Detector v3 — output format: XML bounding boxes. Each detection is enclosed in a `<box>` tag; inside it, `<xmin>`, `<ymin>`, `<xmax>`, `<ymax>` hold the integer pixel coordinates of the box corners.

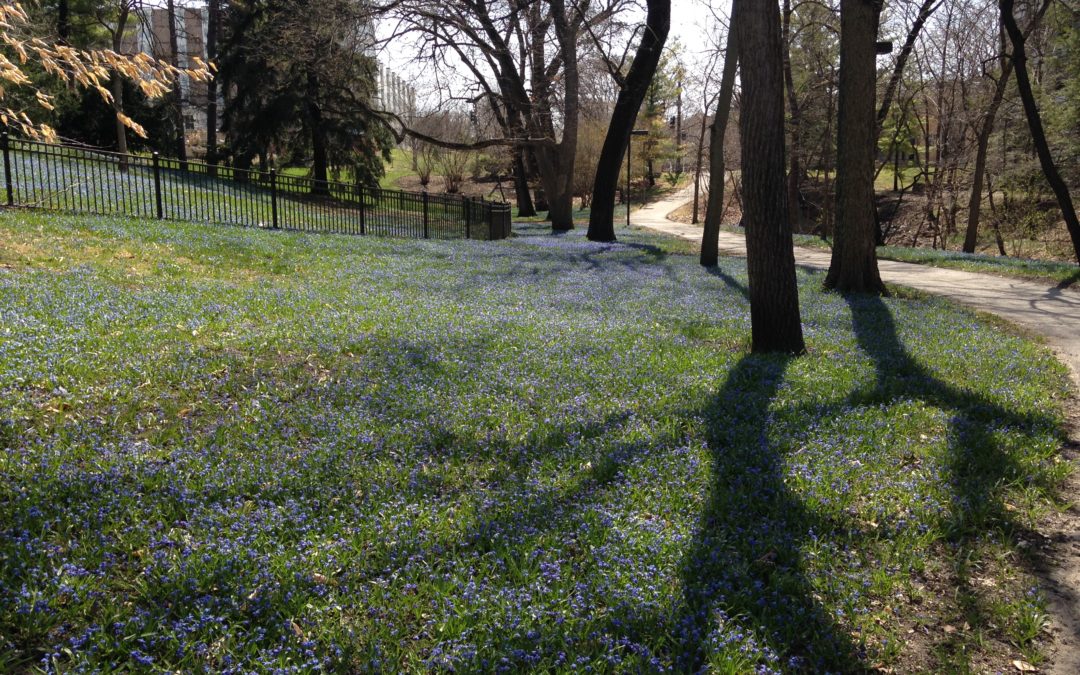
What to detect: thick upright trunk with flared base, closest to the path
<box><xmin>825</xmin><ymin>0</ymin><xmax>886</xmax><ymax>295</ymax></box>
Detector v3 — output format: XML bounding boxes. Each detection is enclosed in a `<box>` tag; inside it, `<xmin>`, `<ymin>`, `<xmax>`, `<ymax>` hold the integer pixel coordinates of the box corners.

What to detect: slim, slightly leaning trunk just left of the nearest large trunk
<box><xmin>701</xmin><ymin>17</ymin><xmax>739</xmax><ymax>267</ymax></box>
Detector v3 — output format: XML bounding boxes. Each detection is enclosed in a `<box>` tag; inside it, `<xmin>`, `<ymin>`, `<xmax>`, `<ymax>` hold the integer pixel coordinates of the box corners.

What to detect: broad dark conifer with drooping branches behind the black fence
<box><xmin>219</xmin><ymin>0</ymin><xmax>393</xmax><ymax>185</ymax></box>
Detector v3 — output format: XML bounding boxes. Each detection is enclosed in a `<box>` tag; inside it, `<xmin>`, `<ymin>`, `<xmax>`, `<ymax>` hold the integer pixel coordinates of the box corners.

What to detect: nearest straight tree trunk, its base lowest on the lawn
<box><xmin>732</xmin><ymin>0</ymin><xmax>806</xmax><ymax>354</ymax></box>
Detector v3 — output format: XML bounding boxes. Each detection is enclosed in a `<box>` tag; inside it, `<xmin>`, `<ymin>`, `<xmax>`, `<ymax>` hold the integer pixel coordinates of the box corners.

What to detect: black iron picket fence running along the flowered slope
<box><xmin>0</xmin><ymin>134</ymin><xmax>510</xmax><ymax>239</ymax></box>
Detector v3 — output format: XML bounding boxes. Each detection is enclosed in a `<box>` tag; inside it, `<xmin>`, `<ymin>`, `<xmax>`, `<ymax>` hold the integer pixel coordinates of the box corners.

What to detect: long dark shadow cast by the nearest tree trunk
<box><xmin>674</xmin><ymin>355</ymin><xmax>861</xmax><ymax>672</ymax></box>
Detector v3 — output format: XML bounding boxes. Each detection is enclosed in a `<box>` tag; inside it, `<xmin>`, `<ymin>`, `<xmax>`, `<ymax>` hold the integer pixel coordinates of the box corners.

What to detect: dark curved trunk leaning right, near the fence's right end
<box><xmin>588</xmin><ymin>0</ymin><xmax>672</xmax><ymax>242</ymax></box>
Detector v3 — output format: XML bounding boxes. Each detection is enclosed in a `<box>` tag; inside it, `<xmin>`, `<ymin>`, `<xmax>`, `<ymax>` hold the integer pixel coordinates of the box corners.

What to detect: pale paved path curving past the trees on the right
<box><xmin>631</xmin><ymin>191</ymin><xmax>1080</xmax><ymax>675</ymax></box>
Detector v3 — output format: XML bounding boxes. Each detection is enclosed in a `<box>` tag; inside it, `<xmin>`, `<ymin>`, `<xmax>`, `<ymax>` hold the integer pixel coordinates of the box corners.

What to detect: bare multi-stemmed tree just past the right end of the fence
<box><xmin>381</xmin><ymin>0</ymin><xmax>623</xmax><ymax>231</ymax></box>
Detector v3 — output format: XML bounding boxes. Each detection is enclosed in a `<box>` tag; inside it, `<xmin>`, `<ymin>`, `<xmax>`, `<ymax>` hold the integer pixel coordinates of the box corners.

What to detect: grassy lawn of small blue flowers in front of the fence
<box><xmin>0</xmin><ymin>212</ymin><xmax>1068</xmax><ymax>673</ymax></box>
